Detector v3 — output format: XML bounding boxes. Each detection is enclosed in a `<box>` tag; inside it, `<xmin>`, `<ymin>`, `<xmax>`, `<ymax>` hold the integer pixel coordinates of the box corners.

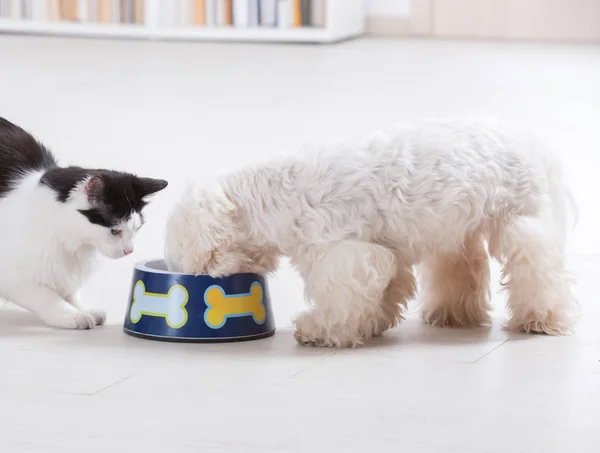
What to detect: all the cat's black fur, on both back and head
<box><xmin>0</xmin><ymin>118</ymin><xmax>167</xmax><ymax>228</ymax></box>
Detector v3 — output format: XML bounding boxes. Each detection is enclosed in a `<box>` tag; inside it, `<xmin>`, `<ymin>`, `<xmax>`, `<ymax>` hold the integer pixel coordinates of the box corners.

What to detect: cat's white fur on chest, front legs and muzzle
<box><xmin>0</xmin><ymin>172</ymin><xmax>141</xmax><ymax>329</ymax></box>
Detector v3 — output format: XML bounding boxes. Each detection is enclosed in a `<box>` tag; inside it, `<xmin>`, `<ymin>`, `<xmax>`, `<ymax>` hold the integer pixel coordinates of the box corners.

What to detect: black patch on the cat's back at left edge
<box><xmin>0</xmin><ymin>117</ymin><xmax>56</xmax><ymax>198</ymax></box>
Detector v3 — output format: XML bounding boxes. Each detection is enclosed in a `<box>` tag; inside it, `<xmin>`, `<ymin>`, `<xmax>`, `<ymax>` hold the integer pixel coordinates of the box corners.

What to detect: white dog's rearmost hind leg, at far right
<box><xmin>490</xmin><ymin>217</ymin><xmax>579</xmax><ymax>335</ymax></box>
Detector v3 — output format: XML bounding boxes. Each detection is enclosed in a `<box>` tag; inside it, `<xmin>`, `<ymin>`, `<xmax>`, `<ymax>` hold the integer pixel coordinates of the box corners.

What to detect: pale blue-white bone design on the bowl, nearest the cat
<box><xmin>129</xmin><ymin>280</ymin><xmax>189</xmax><ymax>329</ymax></box>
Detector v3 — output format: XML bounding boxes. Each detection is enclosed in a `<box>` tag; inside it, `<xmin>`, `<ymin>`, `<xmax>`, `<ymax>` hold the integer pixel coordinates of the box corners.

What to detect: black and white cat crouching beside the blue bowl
<box><xmin>0</xmin><ymin>118</ymin><xmax>167</xmax><ymax>329</ymax></box>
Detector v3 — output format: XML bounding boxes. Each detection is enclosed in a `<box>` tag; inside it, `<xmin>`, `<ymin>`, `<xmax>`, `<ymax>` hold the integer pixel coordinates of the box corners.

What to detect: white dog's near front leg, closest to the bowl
<box><xmin>294</xmin><ymin>241</ymin><xmax>396</xmax><ymax>348</ymax></box>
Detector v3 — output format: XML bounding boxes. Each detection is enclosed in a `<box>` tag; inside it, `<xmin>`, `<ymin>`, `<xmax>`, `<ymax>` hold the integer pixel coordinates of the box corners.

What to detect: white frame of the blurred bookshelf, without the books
<box><xmin>0</xmin><ymin>0</ymin><xmax>365</xmax><ymax>44</ymax></box>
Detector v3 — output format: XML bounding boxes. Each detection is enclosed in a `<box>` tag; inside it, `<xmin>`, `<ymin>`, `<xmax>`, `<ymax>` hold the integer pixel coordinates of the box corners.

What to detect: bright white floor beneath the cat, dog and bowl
<box><xmin>0</xmin><ymin>36</ymin><xmax>600</xmax><ymax>453</ymax></box>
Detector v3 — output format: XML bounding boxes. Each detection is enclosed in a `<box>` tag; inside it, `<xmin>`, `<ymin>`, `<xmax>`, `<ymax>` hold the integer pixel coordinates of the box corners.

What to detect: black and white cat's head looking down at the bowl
<box><xmin>41</xmin><ymin>167</ymin><xmax>167</xmax><ymax>259</ymax></box>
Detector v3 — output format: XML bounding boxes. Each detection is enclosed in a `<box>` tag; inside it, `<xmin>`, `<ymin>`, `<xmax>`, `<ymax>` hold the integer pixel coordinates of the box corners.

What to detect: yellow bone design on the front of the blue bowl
<box><xmin>204</xmin><ymin>282</ymin><xmax>266</xmax><ymax>329</ymax></box>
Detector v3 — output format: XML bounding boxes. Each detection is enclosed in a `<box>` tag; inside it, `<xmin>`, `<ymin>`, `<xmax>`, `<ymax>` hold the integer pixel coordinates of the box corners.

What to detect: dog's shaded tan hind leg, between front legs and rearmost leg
<box><xmin>421</xmin><ymin>234</ymin><xmax>491</xmax><ymax>327</ymax></box>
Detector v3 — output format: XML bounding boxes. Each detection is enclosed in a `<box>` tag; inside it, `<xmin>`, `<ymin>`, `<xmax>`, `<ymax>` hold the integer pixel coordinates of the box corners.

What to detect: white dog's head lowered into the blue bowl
<box><xmin>165</xmin><ymin>183</ymin><xmax>250</xmax><ymax>277</ymax></box>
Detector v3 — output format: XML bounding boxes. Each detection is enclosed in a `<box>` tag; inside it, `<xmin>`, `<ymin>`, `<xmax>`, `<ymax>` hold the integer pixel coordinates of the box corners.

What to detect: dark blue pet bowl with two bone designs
<box><xmin>124</xmin><ymin>260</ymin><xmax>275</xmax><ymax>342</ymax></box>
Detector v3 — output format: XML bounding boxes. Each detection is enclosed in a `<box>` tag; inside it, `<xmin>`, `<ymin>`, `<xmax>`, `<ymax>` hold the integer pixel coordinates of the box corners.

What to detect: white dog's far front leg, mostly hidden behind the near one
<box><xmin>373</xmin><ymin>254</ymin><xmax>417</xmax><ymax>336</ymax></box>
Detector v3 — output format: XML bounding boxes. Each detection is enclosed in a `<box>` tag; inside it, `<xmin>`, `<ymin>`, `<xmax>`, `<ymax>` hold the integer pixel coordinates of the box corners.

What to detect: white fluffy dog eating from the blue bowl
<box><xmin>166</xmin><ymin>119</ymin><xmax>578</xmax><ymax>347</ymax></box>
